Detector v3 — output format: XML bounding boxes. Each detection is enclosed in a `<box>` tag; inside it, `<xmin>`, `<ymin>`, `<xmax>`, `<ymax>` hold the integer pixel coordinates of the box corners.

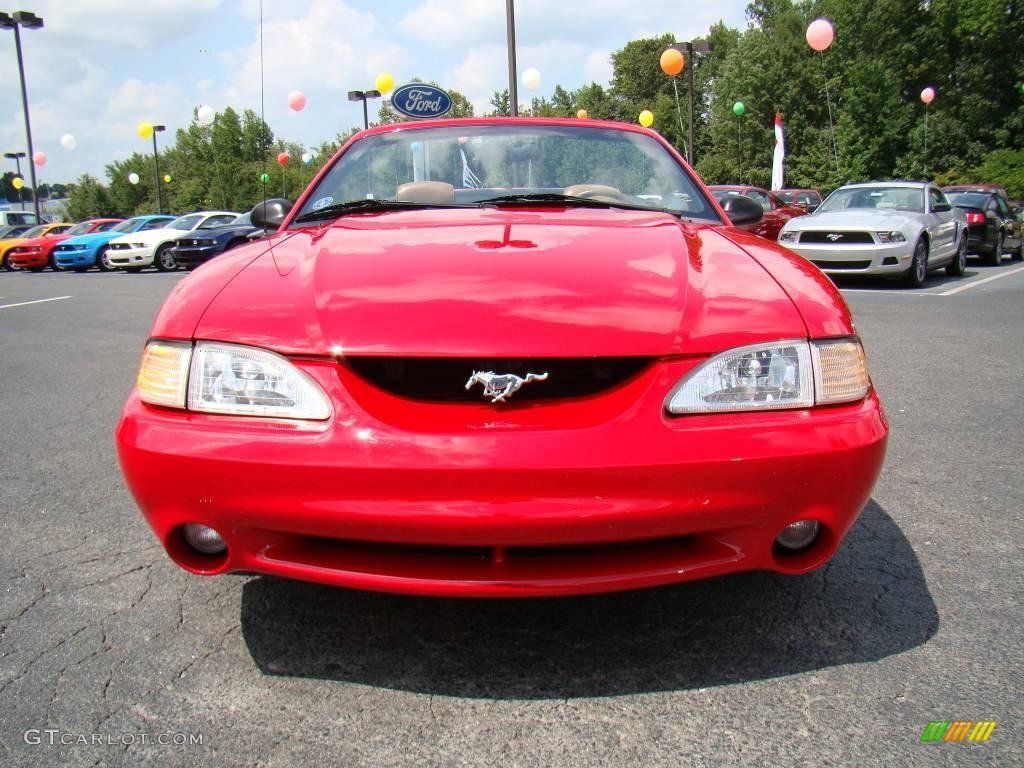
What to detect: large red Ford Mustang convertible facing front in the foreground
<box><xmin>116</xmin><ymin>118</ymin><xmax>888</xmax><ymax>597</ymax></box>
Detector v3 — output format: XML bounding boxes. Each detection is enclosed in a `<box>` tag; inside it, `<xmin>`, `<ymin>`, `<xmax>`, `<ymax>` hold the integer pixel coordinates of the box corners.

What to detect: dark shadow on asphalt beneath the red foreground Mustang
<box><xmin>242</xmin><ymin>502</ymin><xmax>939</xmax><ymax>698</ymax></box>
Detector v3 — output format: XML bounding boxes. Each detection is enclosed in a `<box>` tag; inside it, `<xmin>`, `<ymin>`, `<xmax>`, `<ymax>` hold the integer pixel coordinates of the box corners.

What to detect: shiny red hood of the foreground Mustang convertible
<box><xmin>194</xmin><ymin>209</ymin><xmax>807</xmax><ymax>357</ymax></box>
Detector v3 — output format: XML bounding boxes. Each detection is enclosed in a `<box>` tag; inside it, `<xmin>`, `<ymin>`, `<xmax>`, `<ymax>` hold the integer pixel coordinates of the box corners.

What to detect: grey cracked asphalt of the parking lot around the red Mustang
<box><xmin>0</xmin><ymin>258</ymin><xmax>1024</xmax><ymax>768</ymax></box>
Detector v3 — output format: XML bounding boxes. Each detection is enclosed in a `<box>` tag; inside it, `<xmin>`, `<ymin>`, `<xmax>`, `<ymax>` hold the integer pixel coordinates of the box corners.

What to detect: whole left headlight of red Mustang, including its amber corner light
<box><xmin>137</xmin><ymin>341</ymin><xmax>331</xmax><ymax>420</ymax></box>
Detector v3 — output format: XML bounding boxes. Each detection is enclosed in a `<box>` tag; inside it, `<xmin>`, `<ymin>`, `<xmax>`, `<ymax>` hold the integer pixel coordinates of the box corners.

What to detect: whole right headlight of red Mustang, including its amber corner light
<box><xmin>666</xmin><ymin>339</ymin><xmax>868</xmax><ymax>414</ymax></box>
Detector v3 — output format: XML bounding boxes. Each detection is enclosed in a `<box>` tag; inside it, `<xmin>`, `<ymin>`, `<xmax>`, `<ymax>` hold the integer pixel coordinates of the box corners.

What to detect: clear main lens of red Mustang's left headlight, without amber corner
<box><xmin>188</xmin><ymin>342</ymin><xmax>331</xmax><ymax>420</ymax></box>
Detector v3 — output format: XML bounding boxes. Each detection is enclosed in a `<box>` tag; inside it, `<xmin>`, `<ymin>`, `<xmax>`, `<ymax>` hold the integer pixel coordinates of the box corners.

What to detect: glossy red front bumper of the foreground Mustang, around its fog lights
<box><xmin>117</xmin><ymin>360</ymin><xmax>888</xmax><ymax>597</ymax></box>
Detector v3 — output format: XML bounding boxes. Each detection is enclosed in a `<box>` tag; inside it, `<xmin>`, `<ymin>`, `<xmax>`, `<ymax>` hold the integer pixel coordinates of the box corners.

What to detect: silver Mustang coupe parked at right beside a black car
<box><xmin>778</xmin><ymin>181</ymin><xmax>967</xmax><ymax>288</ymax></box>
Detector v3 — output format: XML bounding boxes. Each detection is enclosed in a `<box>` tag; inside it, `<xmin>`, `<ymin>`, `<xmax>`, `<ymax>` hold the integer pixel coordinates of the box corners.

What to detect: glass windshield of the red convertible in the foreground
<box><xmin>292</xmin><ymin>124</ymin><xmax>720</xmax><ymax>226</ymax></box>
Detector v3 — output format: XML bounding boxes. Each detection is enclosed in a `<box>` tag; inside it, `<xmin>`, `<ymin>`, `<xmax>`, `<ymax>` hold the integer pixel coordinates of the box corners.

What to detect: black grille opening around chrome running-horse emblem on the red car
<box><xmin>345</xmin><ymin>357</ymin><xmax>651</xmax><ymax>403</ymax></box>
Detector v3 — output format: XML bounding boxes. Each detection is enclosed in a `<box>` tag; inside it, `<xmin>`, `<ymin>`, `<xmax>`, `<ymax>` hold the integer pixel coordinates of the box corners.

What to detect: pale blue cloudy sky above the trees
<box><xmin>0</xmin><ymin>0</ymin><xmax>748</xmax><ymax>183</ymax></box>
